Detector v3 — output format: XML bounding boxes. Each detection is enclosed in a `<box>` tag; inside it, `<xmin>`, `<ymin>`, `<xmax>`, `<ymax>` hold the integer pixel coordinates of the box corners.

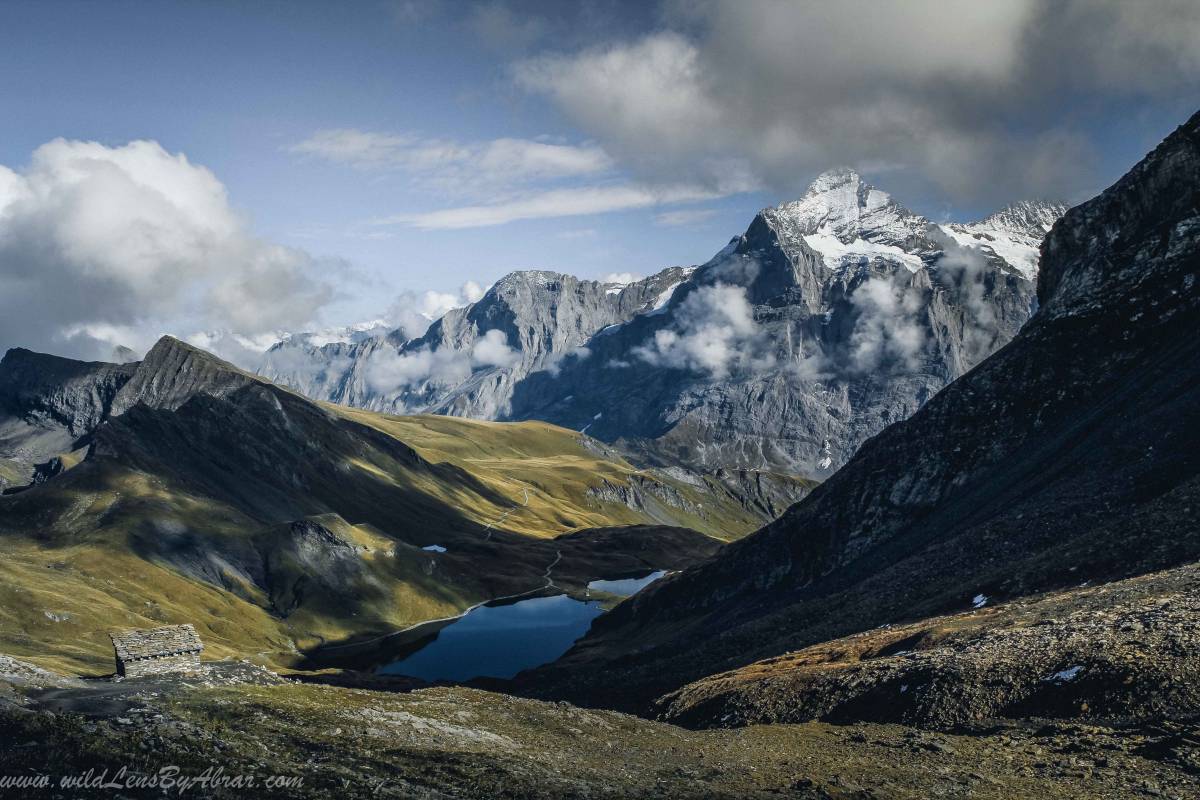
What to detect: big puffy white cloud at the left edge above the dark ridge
<box><xmin>0</xmin><ymin>139</ymin><xmax>332</xmax><ymax>359</ymax></box>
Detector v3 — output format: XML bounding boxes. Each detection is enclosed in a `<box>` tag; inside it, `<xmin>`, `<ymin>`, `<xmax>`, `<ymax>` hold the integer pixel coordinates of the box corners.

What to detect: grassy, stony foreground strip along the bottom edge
<box><xmin>0</xmin><ymin>682</ymin><xmax>1200</xmax><ymax>800</ymax></box>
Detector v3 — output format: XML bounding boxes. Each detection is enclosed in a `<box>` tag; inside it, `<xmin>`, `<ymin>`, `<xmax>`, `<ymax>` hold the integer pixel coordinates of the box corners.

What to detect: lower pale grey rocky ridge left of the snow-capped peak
<box><xmin>259</xmin><ymin>267</ymin><xmax>691</xmax><ymax>419</ymax></box>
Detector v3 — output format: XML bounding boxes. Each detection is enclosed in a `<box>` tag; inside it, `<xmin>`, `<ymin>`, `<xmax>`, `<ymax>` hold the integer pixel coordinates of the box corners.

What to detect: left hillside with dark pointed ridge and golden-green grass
<box><xmin>0</xmin><ymin>338</ymin><xmax>792</xmax><ymax>674</ymax></box>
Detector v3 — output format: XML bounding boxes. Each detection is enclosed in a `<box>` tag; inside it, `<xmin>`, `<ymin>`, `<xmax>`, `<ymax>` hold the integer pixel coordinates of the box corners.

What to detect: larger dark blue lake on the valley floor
<box><xmin>379</xmin><ymin>595</ymin><xmax>602</xmax><ymax>680</ymax></box>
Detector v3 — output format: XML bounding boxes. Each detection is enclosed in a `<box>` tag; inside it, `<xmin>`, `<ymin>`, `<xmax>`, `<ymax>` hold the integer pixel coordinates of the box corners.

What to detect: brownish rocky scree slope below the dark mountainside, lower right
<box><xmin>656</xmin><ymin>564</ymin><xmax>1200</xmax><ymax>734</ymax></box>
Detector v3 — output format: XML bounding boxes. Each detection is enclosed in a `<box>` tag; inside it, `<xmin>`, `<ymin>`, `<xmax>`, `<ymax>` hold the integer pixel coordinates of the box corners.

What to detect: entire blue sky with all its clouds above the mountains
<box><xmin>0</xmin><ymin>0</ymin><xmax>1200</xmax><ymax>359</ymax></box>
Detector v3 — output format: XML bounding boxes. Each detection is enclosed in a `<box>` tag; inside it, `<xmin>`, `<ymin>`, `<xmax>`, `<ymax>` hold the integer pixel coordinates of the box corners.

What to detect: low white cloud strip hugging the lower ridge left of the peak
<box><xmin>365</xmin><ymin>329</ymin><xmax>521</xmax><ymax>392</ymax></box>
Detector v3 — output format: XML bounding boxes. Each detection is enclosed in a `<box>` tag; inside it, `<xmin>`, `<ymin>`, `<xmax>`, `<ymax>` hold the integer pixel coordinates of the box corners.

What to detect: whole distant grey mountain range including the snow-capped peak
<box><xmin>260</xmin><ymin>170</ymin><xmax>1064</xmax><ymax>479</ymax></box>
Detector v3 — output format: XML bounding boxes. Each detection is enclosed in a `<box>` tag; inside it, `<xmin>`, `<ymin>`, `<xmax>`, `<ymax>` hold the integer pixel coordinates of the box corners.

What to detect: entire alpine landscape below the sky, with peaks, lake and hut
<box><xmin>0</xmin><ymin>61</ymin><xmax>1200</xmax><ymax>800</ymax></box>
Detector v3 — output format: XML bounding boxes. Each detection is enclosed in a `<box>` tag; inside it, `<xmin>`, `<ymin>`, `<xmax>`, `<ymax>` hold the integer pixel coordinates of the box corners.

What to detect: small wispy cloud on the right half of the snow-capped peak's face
<box><xmin>850</xmin><ymin>276</ymin><xmax>925</xmax><ymax>372</ymax></box>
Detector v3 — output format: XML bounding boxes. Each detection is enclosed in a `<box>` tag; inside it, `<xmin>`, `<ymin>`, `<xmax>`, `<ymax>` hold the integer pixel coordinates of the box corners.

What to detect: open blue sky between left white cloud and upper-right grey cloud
<box><xmin>0</xmin><ymin>2</ymin><xmax>766</xmax><ymax>321</ymax></box>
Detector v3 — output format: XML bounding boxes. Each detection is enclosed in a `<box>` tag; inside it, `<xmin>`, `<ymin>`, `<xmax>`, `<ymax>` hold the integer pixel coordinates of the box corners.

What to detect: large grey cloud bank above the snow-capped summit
<box><xmin>512</xmin><ymin>0</ymin><xmax>1200</xmax><ymax>201</ymax></box>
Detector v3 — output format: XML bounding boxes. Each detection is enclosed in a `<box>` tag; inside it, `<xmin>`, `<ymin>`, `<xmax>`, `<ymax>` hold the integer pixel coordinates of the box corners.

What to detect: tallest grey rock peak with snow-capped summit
<box><xmin>512</xmin><ymin>170</ymin><xmax>1060</xmax><ymax>477</ymax></box>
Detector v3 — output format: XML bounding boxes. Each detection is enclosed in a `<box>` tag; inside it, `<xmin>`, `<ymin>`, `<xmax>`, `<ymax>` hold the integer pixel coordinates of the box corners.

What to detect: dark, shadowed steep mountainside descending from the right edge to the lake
<box><xmin>530</xmin><ymin>114</ymin><xmax>1200</xmax><ymax>724</ymax></box>
